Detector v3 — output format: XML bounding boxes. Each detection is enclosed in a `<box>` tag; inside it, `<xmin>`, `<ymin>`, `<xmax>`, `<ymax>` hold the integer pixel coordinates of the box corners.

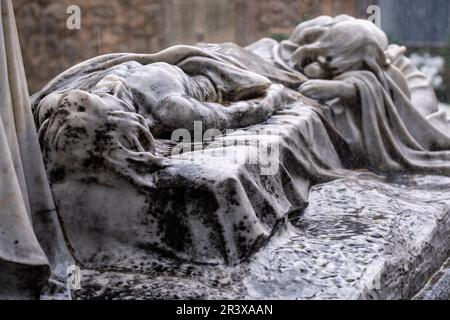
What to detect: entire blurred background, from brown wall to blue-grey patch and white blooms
<box><xmin>13</xmin><ymin>0</ymin><xmax>450</xmax><ymax>103</ymax></box>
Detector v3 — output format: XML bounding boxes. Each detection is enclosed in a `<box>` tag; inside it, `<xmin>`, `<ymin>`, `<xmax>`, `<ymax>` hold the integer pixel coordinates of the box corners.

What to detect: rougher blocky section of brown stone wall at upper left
<box><xmin>13</xmin><ymin>0</ymin><xmax>165</xmax><ymax>93</ymax></box>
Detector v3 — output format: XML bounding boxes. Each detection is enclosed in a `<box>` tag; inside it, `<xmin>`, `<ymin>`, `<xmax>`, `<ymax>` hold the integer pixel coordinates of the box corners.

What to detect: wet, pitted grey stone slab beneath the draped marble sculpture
<box><xmin>69</xmin><ymin>173</ymin><xmax>450</xmax><ymax>299</ymax></box>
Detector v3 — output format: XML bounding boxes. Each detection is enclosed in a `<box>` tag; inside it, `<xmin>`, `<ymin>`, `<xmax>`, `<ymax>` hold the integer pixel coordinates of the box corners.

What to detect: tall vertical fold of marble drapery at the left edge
<box><xmin>0</xmin><ymin>0</ymin><xmax>69</xmax><ymax>298</ymax></box>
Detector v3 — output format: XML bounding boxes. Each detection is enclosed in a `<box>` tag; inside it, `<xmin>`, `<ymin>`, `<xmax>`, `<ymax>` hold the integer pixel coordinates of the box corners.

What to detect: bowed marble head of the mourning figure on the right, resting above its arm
<box><xmin>282</xmin><ymin>15</ymin><xmax>388</xmax><ymax>82</ymax></box>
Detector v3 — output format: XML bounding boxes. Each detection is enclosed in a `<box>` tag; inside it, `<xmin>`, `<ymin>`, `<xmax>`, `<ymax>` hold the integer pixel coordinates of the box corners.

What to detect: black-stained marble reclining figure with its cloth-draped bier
<box><xmin>32</xmin><ymin>44</ymin><xmax>351</xmax><ymax>268</ymax></box>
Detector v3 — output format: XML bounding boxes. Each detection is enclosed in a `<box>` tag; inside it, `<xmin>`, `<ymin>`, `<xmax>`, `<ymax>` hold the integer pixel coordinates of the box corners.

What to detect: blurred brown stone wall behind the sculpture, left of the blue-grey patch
<box><xmin>13</xmin><ymin>0</ymin><xmax>366</xmax><ymax>93</ymax></box>
